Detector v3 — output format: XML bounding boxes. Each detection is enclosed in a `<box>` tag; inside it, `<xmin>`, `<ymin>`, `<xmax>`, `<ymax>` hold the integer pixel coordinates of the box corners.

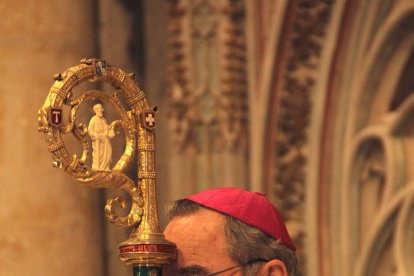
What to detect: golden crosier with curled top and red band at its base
<box><xmin>38</xmin><ymin>59</ymin><xmax>176</xmax><ymax>266</ymax></box>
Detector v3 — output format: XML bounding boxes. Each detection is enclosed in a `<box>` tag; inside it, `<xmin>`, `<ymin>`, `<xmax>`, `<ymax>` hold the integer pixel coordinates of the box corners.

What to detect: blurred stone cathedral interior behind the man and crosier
<box><xmin>0</xmin><ymin>0</ymin><xmax>414</xmax><ymax>276</ymax></box>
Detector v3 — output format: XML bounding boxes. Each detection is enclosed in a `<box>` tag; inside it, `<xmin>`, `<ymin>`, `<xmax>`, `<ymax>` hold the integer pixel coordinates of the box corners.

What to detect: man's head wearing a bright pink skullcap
<box><xmin>164</xmin><ymin>188</ymin><xmax>297</xmax><ymax>276</ymax></box>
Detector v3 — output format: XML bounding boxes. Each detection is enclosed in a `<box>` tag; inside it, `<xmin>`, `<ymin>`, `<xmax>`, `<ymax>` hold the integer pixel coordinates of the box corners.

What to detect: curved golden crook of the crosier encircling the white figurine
<box><xmin>38</xmin><ymin>59</ymin><xmax>153</xmax><ymax>227</ymax></box>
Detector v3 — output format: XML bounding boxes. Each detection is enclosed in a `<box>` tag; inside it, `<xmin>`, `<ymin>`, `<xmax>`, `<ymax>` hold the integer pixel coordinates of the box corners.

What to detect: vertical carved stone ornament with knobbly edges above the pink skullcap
<box><xmin>169</xmin><ymin>0</ymin><xmax>247</xmax><ymax>149</ymax></box>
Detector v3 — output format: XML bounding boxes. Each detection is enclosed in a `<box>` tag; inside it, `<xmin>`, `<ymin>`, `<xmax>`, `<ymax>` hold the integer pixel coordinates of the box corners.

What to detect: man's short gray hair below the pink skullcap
<box><xmin>168</xmin><ymin>199</ymin><xmax>298</xmax><ymax>276</ymax></box>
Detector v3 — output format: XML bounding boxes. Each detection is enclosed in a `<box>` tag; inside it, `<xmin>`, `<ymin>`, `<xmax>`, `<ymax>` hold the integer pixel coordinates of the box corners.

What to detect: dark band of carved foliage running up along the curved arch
<box><xmin>273</xmin><ymin>0</ymin><xmax>334</xmax><ymax>272</ymax></box>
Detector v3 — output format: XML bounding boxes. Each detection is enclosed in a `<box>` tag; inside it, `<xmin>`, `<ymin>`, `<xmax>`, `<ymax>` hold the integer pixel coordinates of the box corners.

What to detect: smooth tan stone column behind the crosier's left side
<box><xmin>0</xmin><ymin>0</ymin><xmax>105</xmax><ymax>276</ymax></box>
